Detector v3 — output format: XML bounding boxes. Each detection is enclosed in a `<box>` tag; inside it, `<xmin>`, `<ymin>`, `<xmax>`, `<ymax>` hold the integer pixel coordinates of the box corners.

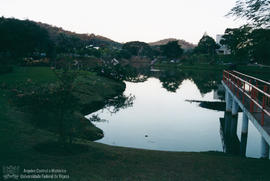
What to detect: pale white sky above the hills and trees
<box><xmin>0</xmin><ymin>0</ymin><xmax>244</xmax><ymax>44</ymax></box>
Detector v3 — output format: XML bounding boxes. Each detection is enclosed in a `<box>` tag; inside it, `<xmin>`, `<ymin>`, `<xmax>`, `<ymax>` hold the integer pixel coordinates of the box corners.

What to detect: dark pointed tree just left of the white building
<box><xmin>194</xmin><ymin>35</ymin><xmax>219</xmax><ymax>56</ymax></box>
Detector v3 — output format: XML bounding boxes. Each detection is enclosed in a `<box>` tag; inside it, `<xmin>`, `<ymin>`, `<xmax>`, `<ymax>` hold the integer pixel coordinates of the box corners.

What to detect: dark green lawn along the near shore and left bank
<box><xmin>0</xmin><ymin>67</ymin><xmax>270</xmax><ymax>181</ymax></box>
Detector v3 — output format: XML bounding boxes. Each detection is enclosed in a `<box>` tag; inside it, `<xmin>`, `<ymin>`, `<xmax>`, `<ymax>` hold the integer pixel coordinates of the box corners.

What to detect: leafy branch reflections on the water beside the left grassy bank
<box><xmin>88</xmin><ymin>94</ymin><xmax>135</xmax><ymax>122</ymax></box>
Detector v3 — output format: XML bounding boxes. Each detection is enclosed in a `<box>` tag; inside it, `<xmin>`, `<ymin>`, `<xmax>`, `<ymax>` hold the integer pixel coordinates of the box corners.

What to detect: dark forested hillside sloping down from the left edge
<box><xmin>0</xmin><ymin>17</ymin><xmax>122</xmax><ymax>57</ymax></box>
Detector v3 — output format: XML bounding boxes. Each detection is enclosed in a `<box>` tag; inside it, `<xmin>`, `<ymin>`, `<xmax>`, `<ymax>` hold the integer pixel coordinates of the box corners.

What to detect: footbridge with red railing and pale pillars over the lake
<box><xmin>222</xmin><ymin>71</ymin><xmax>270</xmax><ymax>158</ymax></box>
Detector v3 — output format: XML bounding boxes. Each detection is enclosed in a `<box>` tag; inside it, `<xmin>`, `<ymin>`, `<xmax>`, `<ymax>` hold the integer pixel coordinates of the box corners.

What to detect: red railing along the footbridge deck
<box><xmin>223</xmin><ymin>71</ymin><xmax>270</xmax><ymax>126</ymax></box>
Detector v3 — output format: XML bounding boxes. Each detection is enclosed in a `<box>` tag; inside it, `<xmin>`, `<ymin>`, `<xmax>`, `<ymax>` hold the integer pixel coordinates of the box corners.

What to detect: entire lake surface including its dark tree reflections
<box><xmin>88</xmin><ymin>67</ymin><xmax>258</xmax><ymax>157</ymax></box>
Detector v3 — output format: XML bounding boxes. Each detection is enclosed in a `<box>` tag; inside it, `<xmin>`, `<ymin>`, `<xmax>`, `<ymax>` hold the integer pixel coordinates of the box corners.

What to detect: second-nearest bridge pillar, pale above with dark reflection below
<box><xmin>240</xmin><ymin>112</ymin><xmax>248</xmax><ymax>157</ymax></box>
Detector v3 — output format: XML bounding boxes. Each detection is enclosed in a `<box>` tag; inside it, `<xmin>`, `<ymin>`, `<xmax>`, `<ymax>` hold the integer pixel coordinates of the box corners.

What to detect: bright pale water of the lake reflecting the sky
<box><xmin>87</xmin><ymin>70</ymin><xmax>260</xmax><ymax>158</ymax></box>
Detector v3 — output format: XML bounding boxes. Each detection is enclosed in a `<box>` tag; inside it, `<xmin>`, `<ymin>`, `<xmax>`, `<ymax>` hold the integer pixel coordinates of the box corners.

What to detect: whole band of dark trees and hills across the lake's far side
<box><xmin>0</xmin><ymin>17</ymin><xmax>270</xmax><ymax>69</ymax></box>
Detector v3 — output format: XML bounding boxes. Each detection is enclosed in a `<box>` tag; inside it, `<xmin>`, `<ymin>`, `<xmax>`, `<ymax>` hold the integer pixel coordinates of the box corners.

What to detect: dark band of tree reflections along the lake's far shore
<box><xmin>100</xmin><ymin>64</ymin><xmax>222</xmax><ymax>94</ymax></box>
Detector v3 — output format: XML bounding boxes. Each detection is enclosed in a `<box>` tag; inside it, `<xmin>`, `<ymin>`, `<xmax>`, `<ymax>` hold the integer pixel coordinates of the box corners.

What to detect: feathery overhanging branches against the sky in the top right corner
<box><xmin>227</xmin><ymin>0</ymin><xmax>270</xmax><ymax>28</ymax></box>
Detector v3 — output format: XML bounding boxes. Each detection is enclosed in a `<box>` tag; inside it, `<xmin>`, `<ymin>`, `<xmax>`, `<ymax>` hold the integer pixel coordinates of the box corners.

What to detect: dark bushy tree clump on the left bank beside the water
<box><xmin>13</xmin><ymin>70</ymin><xmax>84</xmax><ymax>144</ymax></box>
